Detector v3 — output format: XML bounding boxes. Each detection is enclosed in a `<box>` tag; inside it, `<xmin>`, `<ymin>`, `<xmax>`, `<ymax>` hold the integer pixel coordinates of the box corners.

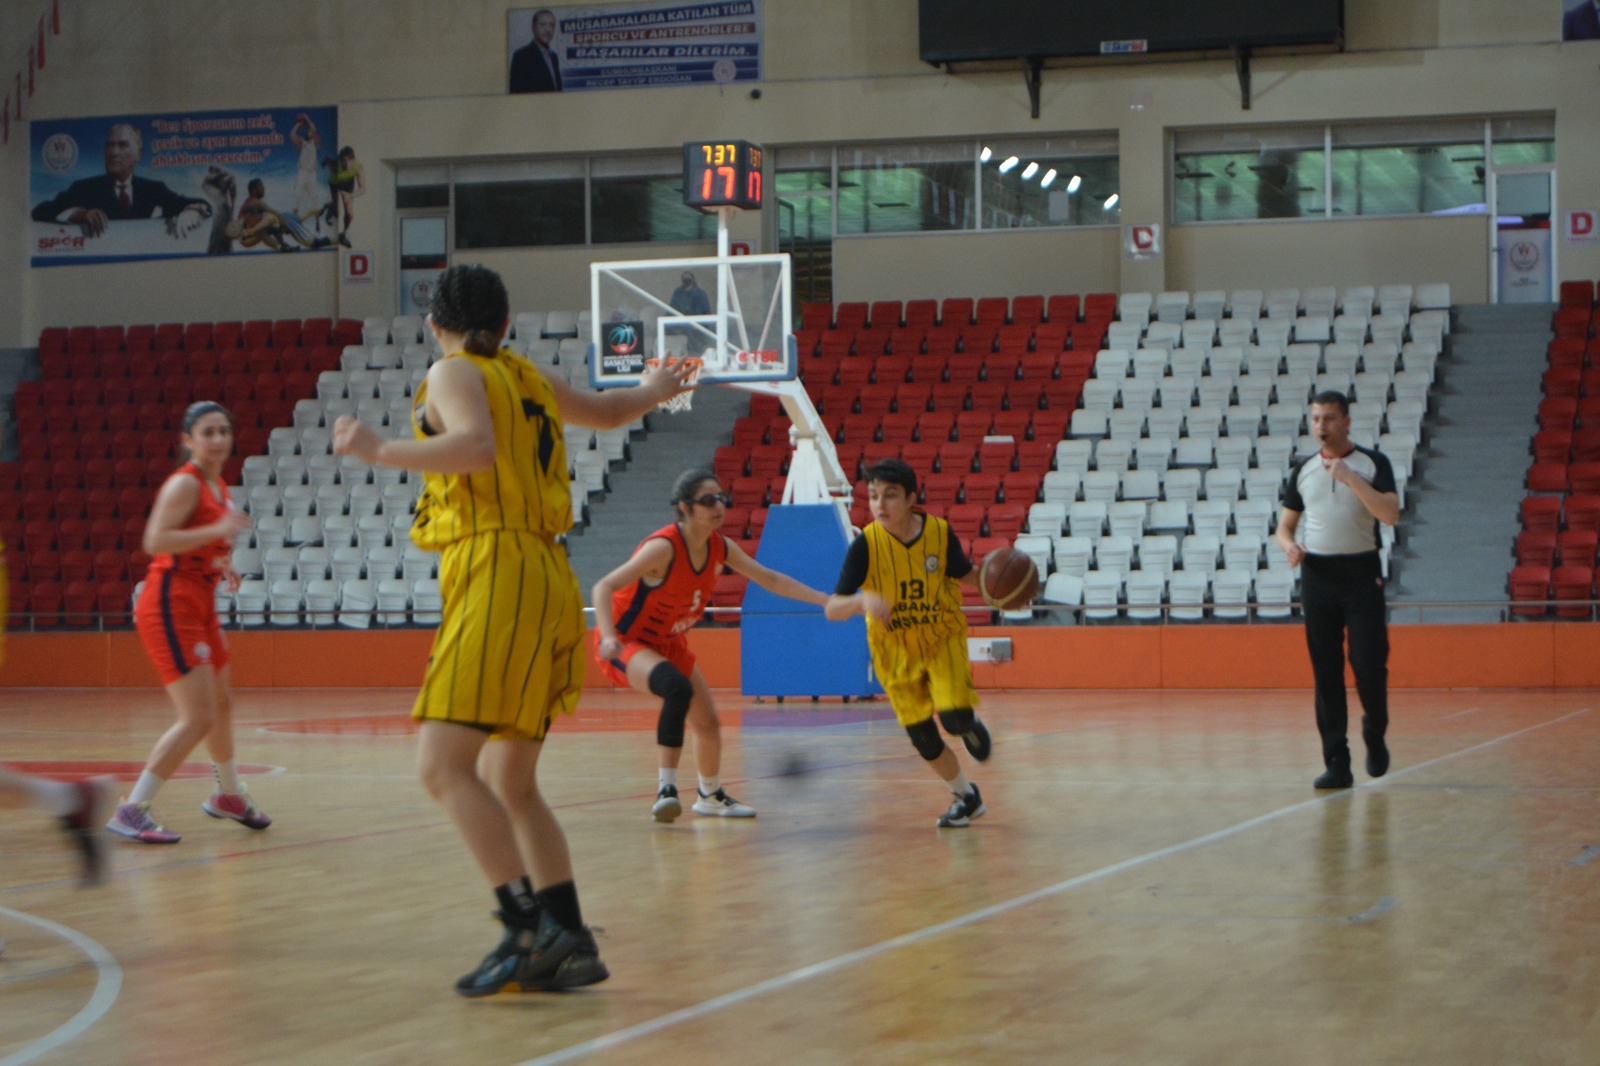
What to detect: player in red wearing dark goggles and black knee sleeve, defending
<box><xmin>594</xmin><ymin>471</ymin><xmax>827</xmax><ymax>821</ymax></box>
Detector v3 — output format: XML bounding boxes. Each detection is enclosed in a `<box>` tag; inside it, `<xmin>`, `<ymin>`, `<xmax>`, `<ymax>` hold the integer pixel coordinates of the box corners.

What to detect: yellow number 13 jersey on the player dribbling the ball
<box><xmin>861</xmin><ymin>507</ymin><xmax>966</xmax><ymax>674</ymax></box>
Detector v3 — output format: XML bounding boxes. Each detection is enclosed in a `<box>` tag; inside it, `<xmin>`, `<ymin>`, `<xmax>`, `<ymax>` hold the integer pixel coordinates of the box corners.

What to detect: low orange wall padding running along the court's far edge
<box><xmin>0</xmin><ymin>623</ymin><xmax>1600</xmax><ymax>688</ymax></box>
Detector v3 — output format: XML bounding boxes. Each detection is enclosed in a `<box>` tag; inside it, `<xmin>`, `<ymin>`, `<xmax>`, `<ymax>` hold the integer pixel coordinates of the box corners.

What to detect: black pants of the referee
<box><xmin>1301</xmin><ymin>552</ymin><xmax>1389</xmax><ymax>767</ymax></box>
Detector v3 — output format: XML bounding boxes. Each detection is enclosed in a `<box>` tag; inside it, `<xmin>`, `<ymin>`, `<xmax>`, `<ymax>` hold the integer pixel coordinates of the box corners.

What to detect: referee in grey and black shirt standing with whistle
<box><xmin>1277</xmin><ymin>385</ymin><xmax>1400</xmax><ymax>789</ymax></box>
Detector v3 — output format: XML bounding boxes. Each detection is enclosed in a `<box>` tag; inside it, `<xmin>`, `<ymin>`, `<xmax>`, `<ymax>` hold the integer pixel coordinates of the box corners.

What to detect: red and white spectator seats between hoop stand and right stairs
<box><xmin>777</xmin><ymin>285</ymin><xmax>1452</xmax><ymax>619</ymax></box>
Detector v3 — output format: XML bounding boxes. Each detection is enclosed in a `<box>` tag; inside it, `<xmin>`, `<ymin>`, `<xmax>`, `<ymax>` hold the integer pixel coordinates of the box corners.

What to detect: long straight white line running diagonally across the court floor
<box><xmin>508</xmin><ymin>707</ymin><xmax>1589</xmax><ymax>1066</ymax></box>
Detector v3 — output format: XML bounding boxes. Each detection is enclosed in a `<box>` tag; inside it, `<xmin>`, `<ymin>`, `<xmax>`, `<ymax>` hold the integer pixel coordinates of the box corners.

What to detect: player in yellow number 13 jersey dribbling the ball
<box><xmin>826</xmin><ymin>459</ymin><xmax>990</xmax><ymax>829</ymax></box>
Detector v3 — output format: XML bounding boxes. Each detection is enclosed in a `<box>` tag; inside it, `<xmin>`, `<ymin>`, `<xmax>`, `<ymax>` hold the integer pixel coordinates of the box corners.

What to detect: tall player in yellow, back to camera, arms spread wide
<box><xmin>333</xmin><ymin>266</ymin><xmax>686</xmax><ymax>996</ymax></box>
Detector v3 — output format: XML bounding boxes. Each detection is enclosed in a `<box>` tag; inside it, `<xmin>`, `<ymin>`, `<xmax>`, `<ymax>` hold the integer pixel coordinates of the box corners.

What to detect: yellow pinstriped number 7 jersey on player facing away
<box><xmin>411</xmin><ymin>347</ymin><xmax>573</xmax><ymax>551</ymax></box>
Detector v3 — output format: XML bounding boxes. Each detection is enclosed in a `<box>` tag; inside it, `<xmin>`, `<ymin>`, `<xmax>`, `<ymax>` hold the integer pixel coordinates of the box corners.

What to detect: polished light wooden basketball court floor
<box><xmin>0</xmin><ymin>690</ymin><xmax>1600</xmax><ymax>1066</ymax></box>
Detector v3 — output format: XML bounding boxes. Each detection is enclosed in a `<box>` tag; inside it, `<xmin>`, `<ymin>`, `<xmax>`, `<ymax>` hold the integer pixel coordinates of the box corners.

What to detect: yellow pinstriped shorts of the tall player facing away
<box><xmin>411</xmin><ymin>530</ymin><xmax>587</xmax><ymax>741</ymax></box>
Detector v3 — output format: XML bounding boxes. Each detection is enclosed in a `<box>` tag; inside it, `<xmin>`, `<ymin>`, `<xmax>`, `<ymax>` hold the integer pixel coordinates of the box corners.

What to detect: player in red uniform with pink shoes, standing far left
<box><xmin>106</xmin><ymin>402</ymin><xmax>272</xmax><ymax>844</ymax></box>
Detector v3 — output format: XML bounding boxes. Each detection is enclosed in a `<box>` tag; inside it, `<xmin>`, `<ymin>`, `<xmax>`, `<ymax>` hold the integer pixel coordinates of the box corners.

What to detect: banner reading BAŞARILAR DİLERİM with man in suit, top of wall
<box><xmin>506</xmin><ymin>0</ymin><xmax>762</xmax><ymax>93</ymax></box>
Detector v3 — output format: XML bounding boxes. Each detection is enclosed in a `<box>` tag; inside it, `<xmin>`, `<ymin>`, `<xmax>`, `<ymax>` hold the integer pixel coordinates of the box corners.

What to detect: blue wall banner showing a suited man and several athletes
<box><xmin>29</xmin><ymin>107</ymin><xmax>347</xmax><ymax>266</ymax></box>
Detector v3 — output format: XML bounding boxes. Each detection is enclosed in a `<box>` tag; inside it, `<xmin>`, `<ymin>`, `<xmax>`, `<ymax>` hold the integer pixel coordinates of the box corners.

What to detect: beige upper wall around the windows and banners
<box><xmin>0</xmin><ymin>0</ymin><xmax>1600</xmax><ymax>346</ymax></box>
